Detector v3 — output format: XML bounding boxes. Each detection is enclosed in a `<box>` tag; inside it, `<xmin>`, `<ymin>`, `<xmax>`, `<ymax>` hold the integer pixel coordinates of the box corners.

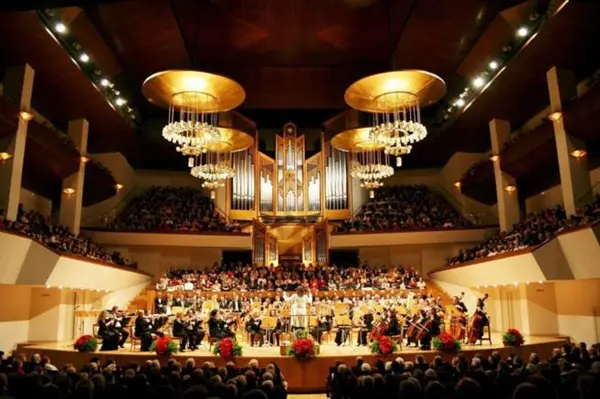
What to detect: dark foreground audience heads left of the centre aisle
<box><xmin>0</xmin><ymin>354</ymin><xmax>287</xmax><ymax>399</ymax></box>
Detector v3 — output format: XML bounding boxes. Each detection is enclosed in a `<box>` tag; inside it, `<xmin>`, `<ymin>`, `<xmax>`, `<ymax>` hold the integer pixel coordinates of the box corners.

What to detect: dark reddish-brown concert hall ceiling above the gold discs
<box><xmin>0</xmin><ymin>0</ymin><xmax>600</xmax><ymax>191</ymax></box>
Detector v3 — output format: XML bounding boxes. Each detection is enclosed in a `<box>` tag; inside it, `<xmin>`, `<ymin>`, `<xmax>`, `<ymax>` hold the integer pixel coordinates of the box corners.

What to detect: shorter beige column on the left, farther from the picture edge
<box><xmin>59</xmin><ymin>119</ymin><xmax>89</xmax><ymax>234</ymax></box>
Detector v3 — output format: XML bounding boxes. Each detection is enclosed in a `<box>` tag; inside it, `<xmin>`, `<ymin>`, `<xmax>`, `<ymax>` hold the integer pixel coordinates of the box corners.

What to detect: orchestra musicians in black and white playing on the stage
<box><xmin>97</xmin><ymin>287</ymin><xmax>489</xmax><ymax>351</ymax></box>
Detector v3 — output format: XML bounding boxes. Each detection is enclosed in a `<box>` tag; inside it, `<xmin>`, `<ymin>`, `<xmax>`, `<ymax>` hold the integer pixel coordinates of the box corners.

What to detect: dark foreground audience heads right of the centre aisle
<box><xmin>327</xmin><ymin>344</ymin><xmax>600</xmax><ymax>399</ymax></box>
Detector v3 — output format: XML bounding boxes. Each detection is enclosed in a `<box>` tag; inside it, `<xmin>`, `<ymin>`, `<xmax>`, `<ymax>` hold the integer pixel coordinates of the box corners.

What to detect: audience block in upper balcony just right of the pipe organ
<box><xmin>337</xmin><ymin>185</ymin><xmax>471</xmax><ymax>232</ymax></box>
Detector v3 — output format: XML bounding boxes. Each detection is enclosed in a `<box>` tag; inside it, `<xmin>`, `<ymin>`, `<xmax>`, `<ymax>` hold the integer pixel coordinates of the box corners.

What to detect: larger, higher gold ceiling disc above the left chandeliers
<box><xmin>142</xmin><ymin>70</ymin><xmax>246</xmax><ymax>112</ymax></box>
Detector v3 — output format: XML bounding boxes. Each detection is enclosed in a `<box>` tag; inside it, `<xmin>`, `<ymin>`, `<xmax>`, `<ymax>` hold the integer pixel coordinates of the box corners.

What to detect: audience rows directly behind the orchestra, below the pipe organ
<box><xmin>156</xmin><ymin>264</ymin><xmax>425</xmax><ymax>292</ymax></box>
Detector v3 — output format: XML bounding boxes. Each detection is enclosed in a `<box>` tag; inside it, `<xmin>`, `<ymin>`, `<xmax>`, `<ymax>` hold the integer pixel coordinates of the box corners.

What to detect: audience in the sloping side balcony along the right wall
<box><xmin>448</xmin><ymin>197</ymin><xmax>600</xmax><ymax>265</ymax></box>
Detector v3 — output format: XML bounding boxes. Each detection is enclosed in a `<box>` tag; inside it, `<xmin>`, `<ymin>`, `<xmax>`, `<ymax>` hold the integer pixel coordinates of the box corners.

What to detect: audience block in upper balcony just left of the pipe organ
<box><xmin>108</xmin><ymin>186</ymin><xmax>240</xmax><ymax>232</ymax></box>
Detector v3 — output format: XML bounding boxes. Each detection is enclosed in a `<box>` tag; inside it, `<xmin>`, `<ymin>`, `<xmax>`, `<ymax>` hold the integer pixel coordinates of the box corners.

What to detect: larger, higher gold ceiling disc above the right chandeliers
<box><xmin>344</xmin><ymin>69</ymin><xmax>446</xmax><ymax>113</ymax></box>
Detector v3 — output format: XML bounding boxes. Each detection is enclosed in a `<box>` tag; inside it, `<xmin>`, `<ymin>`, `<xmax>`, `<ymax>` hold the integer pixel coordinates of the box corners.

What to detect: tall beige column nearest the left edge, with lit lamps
<box><xmin>0</xmin><ymin>64</ymin><xmax>34</xmax><ymax>220</ymax></box>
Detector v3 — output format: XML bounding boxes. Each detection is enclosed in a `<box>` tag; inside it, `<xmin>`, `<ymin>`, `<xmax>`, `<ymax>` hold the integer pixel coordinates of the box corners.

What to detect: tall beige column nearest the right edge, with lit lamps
<box><xmin>546</xmin><ymin>67</ymin><xmax>594</xmax><ymax>215</ymax></box>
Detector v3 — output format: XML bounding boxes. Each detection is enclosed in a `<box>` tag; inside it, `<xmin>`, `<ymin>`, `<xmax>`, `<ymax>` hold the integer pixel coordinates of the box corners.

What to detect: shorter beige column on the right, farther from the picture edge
<box><xmin>490</xmin><ymin>119</ymin><xmax>520</xmax><ymax>231</ymax></box>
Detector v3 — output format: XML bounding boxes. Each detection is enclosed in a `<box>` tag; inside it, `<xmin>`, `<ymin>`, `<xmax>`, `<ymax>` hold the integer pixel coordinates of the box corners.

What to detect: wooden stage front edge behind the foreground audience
<box><xmin>16</xmin><ymin>333</ymin><xmax>569</xmax><ymax>393</ymax></box>
